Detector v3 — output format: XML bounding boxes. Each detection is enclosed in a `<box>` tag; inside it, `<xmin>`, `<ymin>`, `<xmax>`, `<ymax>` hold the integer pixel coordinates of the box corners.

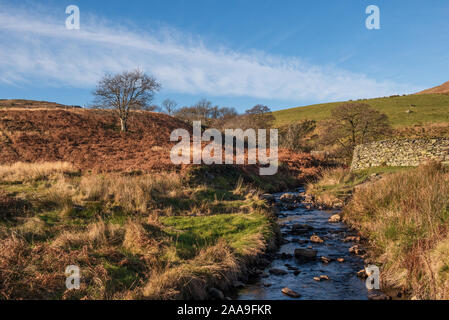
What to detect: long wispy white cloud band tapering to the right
<box><xmin>0</xmin><ymin>4</ymin><xmax>417</xmax><ymax>101</ymax></box>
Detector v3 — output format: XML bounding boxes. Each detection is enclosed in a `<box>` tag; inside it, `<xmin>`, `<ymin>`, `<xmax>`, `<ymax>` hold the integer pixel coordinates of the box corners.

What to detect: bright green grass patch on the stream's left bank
<box><xmin>160</xmin><ymin>213</ymin><xmax>272</xmax><ymax>258</ymax></box>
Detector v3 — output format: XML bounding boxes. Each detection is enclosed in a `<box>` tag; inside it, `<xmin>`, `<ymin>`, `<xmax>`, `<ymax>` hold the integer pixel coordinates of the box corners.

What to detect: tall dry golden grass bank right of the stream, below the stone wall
<box><xmin>345</xmin><ymin>162</ymin><xmax>449</xmax><ymax>299</ymax></box>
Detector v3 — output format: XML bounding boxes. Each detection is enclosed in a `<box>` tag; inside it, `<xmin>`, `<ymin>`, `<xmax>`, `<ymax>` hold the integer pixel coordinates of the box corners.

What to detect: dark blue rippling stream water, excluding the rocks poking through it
<box><xmin>239</xmin><ymin>190</ymin><xmax>368</xmax><ymax>300</ymax></box>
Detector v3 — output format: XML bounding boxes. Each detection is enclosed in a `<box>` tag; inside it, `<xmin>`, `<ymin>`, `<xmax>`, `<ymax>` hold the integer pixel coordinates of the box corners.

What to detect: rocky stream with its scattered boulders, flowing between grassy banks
<box><xmin>238</xmin><ymin>190</ymin><xmax>386</xmax><ymax>300</ymax></box>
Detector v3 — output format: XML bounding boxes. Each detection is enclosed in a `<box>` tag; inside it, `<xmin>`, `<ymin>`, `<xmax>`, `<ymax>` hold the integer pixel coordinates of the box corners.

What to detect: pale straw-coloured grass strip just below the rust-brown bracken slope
<box><xmin>16</xmin><ymin>169</ymin><xmax>184</xmax><ymax>217</ymax></box>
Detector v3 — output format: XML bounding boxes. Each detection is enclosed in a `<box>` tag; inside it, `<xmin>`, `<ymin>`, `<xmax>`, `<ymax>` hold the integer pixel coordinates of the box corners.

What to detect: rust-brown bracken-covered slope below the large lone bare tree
<box><xmin>0</xmin><ymin>108</ymin><xmax>190</xmax><ymax>171</ymax></box>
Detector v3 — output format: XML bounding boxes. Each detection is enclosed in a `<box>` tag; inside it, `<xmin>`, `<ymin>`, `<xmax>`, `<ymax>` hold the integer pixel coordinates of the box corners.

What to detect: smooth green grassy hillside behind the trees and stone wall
<box><xmin>274</xmin><ymin>94</ymin><xmax>449</xmax><ymax>127</ymax></box>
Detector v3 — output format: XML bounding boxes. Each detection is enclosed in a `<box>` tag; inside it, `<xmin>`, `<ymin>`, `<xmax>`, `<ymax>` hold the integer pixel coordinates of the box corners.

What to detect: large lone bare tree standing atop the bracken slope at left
<box><xmin>94</xmin><ymin>69</ymin><xmax>161</xmax><ymax>132</ymax></box>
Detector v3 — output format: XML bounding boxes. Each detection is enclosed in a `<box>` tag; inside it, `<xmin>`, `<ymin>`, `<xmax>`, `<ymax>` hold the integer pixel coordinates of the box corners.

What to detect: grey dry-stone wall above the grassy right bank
<box><xmin>351</xmin><ymin>138</ymin><xmax>449</xmax><ymax>170</ymax></box>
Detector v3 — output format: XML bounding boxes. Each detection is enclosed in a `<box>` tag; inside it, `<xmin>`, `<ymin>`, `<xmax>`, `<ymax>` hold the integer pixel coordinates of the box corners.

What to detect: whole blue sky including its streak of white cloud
<box><xmin>0</xmin><ymin>0</ymin><xmax>449</xmax><ymax>111</ymax></box>
